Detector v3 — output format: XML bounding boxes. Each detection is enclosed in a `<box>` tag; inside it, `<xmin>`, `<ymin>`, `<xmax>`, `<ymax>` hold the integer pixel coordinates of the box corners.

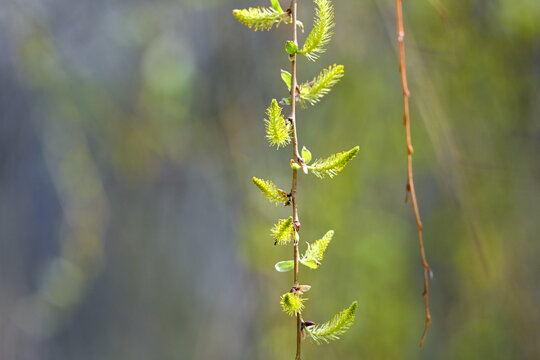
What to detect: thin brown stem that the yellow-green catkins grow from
<box><xmin>289</xmin><ymin>0</ymin><xmax>302</xmax><ymax>360</ymax></box>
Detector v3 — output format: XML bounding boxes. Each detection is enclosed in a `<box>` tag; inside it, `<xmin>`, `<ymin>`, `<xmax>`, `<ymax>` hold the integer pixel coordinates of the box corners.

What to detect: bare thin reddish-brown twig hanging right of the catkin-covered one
<box><xmin>396</xmin><ymin>0</ymin><xmax>431</xmax><ymax>347</ymax></box>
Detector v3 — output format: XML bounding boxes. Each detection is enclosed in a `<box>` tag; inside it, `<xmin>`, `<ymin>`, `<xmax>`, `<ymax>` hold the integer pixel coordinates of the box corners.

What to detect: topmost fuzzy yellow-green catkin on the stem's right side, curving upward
<box><xmin>298</xmin><ymin>0</ymin><xmax>335</xmax><ymax>61</ymax></box>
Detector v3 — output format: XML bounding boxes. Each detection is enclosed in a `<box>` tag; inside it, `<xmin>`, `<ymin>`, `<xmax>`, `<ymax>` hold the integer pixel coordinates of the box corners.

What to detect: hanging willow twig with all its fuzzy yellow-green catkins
<box><xmin>233</xmin><ymin>0</ymin><xmax>359</xmax><ymax>352</ymax></box>
